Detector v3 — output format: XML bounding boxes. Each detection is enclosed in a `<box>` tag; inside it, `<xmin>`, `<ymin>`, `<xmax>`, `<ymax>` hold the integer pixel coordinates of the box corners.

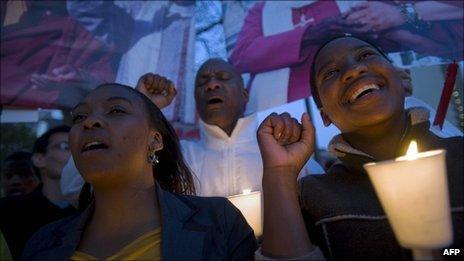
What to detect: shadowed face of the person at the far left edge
<box><xmin>1</xmin><ymin>161</ymin><xmax>40</xmax><ymax>196</ymax></box>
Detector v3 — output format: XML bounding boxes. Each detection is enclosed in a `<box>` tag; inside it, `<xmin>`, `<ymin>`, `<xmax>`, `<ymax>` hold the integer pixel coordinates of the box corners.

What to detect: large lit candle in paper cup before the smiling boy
<box><xmin>364</xmin><ymin>141</ymin><xmax>453</xmax><ymax>258</ymax></box>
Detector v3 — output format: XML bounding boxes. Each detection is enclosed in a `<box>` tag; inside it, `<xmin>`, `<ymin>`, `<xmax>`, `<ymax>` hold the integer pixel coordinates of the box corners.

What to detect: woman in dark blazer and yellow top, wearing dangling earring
<box><xmin>22</xmin><ymin>83</ymin><xmax>256</xmax><ymax>260</ymax></box>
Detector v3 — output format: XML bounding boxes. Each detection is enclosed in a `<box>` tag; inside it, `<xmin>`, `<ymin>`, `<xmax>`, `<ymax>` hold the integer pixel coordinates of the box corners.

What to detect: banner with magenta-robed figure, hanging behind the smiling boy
<box><xmin>224</xmin><ymin>0</ymin><xmax>464</xmax><ymax>115</ymax></box>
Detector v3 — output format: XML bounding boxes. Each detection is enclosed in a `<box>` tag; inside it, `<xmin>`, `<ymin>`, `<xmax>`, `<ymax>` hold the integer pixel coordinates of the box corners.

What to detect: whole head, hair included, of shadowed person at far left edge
<box><xmin>1</xmin><ymin>151</ymin><xmax>40</xmax><ymax>197</ymax></box>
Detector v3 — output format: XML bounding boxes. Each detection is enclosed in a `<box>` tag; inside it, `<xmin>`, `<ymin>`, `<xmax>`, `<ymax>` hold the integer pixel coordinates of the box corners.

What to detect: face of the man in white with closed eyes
<box><xmin>195</xmin><ymin>59</ymin><xmax>248</xmax><ymax>130</ymax></box>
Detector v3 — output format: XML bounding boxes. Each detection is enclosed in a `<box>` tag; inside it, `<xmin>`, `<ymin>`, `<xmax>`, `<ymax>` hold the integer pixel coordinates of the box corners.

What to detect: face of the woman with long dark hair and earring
<box><xmin>70</xmin><ymin>85</ymin><xmax>156</xmax><ymax>187</ymax></box>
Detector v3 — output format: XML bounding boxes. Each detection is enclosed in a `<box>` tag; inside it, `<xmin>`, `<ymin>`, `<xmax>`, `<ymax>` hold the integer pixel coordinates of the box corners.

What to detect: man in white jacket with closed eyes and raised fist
<box><xmin>62</xmin><ymin>58</ymin><xmax>322</xmax><ymax>202</ymax></box>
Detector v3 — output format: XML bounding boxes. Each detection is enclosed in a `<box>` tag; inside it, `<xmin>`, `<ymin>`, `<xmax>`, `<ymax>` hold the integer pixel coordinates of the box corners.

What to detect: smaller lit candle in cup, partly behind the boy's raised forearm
<box><xmin>228</xmin><ymin>189</ymin><xmax>263</xmax><ymax>237</ymax></box>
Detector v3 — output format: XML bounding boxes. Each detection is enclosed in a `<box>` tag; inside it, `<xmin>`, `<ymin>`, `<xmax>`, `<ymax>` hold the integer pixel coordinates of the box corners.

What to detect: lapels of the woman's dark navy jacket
<box><xmin>48</xmin><ymin>184</ymin><xmax>205</xmax><ymax>260</ymax></box>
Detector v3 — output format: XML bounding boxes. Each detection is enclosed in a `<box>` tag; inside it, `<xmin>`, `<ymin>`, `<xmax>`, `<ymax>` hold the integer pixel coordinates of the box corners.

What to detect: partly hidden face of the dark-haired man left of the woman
<box><xmin>33</xmin><ymin>132</ymin><xmax>71</xmax><ymax>179</ymax></box>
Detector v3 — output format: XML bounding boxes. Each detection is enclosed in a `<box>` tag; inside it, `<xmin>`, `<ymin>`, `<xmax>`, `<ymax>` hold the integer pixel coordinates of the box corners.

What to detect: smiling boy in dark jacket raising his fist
<box><xmin>257</xmin><ymin>37</ymin><xmax>464</xmax><ymax>260</ymax></box>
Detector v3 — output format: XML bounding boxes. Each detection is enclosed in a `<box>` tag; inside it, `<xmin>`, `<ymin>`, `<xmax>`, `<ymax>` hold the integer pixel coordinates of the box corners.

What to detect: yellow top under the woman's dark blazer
<box><xmin>71</xmin><ymin>228</ymin><xmax>161</xmax><ymax>261</ymax></box>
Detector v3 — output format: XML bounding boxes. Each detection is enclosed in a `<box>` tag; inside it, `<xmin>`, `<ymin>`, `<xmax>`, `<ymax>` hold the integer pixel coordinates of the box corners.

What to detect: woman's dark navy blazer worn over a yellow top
<box><xmin>21</xmin><ymin>186</ymin><xmax>257</xmax><ymax>260</ymax></box>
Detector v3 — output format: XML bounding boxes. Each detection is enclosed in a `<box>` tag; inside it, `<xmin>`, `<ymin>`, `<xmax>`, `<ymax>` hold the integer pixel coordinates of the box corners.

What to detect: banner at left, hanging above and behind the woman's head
<box><xmin>1</xmin><ymin>0</ymin><xmax>195</xmax><ymax>121</ymax></box>
